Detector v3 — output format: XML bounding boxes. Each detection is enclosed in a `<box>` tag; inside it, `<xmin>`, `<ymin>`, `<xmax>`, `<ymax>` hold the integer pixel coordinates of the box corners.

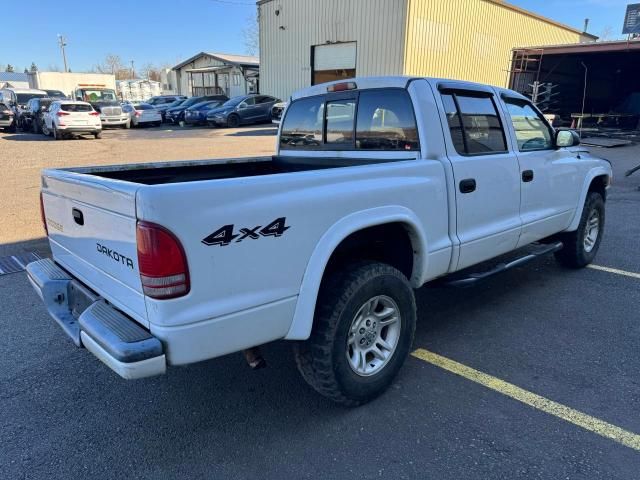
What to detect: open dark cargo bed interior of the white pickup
<box><xmin>71</xmin><ymin>156</ymin><xmax>400</xmax><ymax>185</ymax></box>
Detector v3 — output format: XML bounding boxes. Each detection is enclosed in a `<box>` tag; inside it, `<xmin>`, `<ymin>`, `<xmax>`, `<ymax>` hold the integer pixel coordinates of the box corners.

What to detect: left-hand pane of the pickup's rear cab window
<box><xmin>280</xmin><ymin>97</ymin><xmax>324</xmax><ymax>148</ymax></box>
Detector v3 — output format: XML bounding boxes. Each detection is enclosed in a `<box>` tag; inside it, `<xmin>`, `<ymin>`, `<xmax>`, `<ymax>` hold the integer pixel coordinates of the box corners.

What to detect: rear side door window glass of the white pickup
<box><xmin>442</xmin><ymin>92</ymin><xmax>507</xmax><ymax>155</ymax></box>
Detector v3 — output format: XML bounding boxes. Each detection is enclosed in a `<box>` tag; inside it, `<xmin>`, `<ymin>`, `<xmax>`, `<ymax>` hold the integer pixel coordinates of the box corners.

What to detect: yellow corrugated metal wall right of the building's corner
<box><xmin>404</xmin><ymin>0</ymin><xmax>581</xmax><ymax>87</ymax></box>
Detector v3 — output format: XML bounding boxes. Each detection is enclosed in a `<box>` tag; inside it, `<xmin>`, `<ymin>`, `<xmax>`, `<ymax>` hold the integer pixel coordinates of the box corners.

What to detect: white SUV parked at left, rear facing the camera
<box><xmin>42</xmin><ymin>100</ymin><xmax>102</xmax><ymax>140</ymax></box>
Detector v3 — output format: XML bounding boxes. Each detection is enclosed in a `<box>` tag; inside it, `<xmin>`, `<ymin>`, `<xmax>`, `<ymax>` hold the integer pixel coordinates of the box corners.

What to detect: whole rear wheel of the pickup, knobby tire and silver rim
<box><xmin>294</xmin><ymin>262</ymin><xmax>416</xmax><ymax>406</ymax></box>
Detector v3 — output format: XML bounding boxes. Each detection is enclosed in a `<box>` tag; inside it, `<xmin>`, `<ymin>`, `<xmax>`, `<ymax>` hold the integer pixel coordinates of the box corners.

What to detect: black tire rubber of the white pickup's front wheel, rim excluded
<box><xmin>555</xmin><ymin>192</ymin><xmax>605</xmax><ymax>268</ymax></box>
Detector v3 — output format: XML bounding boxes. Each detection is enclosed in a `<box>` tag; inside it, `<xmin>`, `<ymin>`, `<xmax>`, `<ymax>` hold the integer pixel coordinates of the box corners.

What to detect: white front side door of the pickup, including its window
<box><xmin>502</xmin><ymin>95</ymin><xmax>583</xmax><ymax>246</ymax></box>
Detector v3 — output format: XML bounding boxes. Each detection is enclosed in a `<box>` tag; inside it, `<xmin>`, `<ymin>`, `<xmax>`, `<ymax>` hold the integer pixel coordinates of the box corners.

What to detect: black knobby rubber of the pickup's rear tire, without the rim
<box><xmin>293</xmin><ymin>262</ymin><xmax>416</xmax><ymax>407</ymax></box>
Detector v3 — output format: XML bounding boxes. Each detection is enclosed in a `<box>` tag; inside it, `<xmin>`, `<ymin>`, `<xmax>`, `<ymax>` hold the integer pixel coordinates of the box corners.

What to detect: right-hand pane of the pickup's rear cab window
<box><xmin>356</xmin><ymin>90</ymin><xmax>419</xmax><ymax>150</ymax></box>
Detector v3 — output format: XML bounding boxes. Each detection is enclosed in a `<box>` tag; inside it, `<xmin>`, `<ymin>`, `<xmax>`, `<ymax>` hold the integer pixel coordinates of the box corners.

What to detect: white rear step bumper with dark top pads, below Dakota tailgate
<box><xmin>27</xmin><ymin>259</ymin><xmax>167</xmax><ymax>379</ymax></box>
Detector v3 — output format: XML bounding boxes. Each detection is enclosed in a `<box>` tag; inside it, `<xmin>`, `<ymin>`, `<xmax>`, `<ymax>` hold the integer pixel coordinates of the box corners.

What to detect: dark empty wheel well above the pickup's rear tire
<box><xmin>325</xmin><ymin>223</ymin><xmax>414</xmax><ymax>279</ymax></box>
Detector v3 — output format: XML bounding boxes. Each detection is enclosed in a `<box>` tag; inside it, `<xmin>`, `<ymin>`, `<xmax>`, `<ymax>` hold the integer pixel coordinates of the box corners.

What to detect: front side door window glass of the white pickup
<box><xmin>504</xmin><ymin>98</ymin><xmax>553</xmax><ymax>152</ymax></box>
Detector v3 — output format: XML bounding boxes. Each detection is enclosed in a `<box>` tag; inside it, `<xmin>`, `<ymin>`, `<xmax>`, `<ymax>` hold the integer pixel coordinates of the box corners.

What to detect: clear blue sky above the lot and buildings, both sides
<box><xmin>0</xmin><ymin>0</ymin><xmax>640</xmax><ymax>71</ymax></box>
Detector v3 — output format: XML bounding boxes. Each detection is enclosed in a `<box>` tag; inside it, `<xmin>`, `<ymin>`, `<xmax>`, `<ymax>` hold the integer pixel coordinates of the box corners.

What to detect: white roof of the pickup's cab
<box><xmin>291</xmin><ymin>75</ymin><xmax>527</xmax><ymax>100</ymax></box>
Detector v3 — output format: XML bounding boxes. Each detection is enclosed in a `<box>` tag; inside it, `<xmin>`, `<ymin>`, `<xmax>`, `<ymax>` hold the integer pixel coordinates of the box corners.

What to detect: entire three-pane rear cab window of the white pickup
<box><xmin>280</xmin><ymin>88</ymin><xmax>420</xmax><ymax>151</ymax></box>
